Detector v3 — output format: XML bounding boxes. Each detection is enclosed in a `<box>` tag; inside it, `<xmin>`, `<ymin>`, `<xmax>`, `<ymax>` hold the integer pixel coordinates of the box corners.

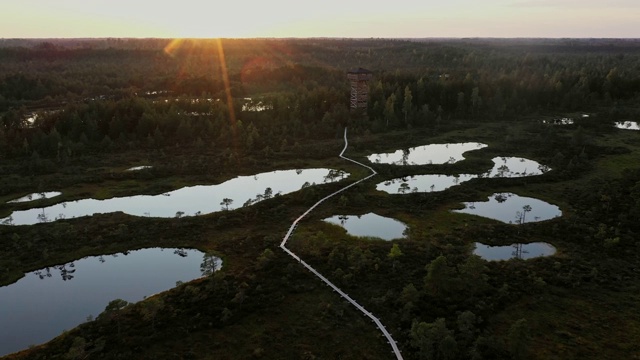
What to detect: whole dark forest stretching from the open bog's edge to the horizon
<box><xmin>0</xmin><ymin>40</ymin><xmax>640</xmax><ymax>172</ymax></box>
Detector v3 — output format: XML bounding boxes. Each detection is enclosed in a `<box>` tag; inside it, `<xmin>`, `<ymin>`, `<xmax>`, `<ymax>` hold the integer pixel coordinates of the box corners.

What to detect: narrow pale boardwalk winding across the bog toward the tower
<box><xmin>280</xmin><ymin>128</ymin><xmax>402</xmax><ymax>360</ymax></box>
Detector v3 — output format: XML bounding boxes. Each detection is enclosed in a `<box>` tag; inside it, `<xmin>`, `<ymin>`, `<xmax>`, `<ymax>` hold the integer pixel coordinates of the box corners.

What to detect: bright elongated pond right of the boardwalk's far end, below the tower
<box><xmin>367</xmin><ymin>142</ymin><xmax>487</xmax><ymax>165</ymax></box>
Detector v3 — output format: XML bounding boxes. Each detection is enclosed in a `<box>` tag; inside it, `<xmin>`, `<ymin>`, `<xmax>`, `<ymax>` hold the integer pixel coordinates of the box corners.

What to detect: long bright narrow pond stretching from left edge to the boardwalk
<box><xmin>0</xmin><ymin>169</ymin><xmax>349</xmax><ymax>225</ymax></box>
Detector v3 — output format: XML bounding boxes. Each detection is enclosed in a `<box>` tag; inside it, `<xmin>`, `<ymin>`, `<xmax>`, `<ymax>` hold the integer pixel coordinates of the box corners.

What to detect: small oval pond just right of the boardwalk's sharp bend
<box><xmin>324</xmin><ymin>213</ymin><xmax>407</xmax><ymax>240</ymax></box>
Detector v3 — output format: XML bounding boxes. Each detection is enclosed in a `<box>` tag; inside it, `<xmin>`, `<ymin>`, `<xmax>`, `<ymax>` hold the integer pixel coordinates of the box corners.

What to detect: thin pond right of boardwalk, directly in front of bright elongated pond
<box><xmin>376</xmin><ymin>174</ymin><xmax>478</xmax><ymax>194</ymax></box>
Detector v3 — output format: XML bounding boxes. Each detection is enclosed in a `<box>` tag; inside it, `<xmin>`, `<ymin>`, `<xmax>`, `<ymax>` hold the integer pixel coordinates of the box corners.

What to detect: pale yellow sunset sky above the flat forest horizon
<box><xmin>0</xmin><ymin>0</ymin><xmax>640</xmax><ymax>38</ymax></box>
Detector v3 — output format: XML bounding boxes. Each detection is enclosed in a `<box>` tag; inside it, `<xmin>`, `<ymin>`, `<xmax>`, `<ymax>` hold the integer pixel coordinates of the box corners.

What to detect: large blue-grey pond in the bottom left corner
<box><xmin>0</xmin><ymin>248</ymin><xmax>222</xmax><ymax>356</ymax></box>
